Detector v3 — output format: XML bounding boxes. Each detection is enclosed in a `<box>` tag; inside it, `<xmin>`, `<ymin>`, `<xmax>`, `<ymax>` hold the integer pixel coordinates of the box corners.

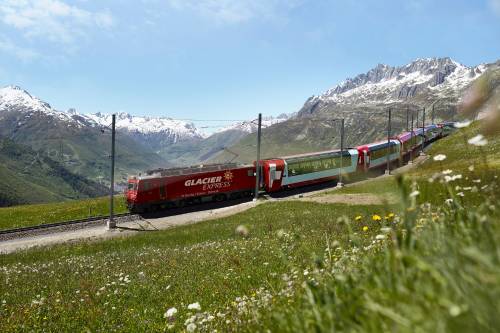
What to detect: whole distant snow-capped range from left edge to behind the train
<box><xmin>0</xmin><ymin>86</ymin><xmax>290</xmax><ymax>170</ymax></box>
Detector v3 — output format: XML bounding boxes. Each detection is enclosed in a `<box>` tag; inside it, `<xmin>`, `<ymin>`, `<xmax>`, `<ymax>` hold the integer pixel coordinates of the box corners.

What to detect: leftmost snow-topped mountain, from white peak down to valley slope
<box><xmin>0</xmin><ymin>87</ymin><xmax>168</xmax><ymax>184</ymax></box>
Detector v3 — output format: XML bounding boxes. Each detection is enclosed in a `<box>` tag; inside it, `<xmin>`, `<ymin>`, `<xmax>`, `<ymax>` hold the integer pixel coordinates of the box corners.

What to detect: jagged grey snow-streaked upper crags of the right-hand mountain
<box><xmin>306</xmin><ymin>58</ymin><xmax>487</xmax><ymax>106</ymax></box>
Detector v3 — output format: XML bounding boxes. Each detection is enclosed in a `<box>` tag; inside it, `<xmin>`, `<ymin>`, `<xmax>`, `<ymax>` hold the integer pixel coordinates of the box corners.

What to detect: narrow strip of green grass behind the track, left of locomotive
<box><xmin>0</xmin><ymin>195</ymin><xmax>127</xmax><ymax>229</ymax></box>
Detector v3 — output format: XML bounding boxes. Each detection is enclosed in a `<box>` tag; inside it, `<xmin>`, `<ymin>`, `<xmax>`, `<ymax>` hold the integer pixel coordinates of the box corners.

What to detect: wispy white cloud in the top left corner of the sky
<box><xmin>0</xmin><ymin>0</ymin><xmax>114</xmax><ymax>44</ymax></box>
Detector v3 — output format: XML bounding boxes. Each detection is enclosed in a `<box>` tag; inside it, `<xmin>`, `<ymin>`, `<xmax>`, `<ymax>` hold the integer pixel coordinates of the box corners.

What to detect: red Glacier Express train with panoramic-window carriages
<box><xmin>125</xmin><ymin>123</ymin><xmax>453</xmax><ymax>212</ymax></box>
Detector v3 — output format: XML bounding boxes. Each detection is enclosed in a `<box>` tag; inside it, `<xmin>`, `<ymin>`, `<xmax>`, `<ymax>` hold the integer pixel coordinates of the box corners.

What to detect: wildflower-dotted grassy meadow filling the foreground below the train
<box><xmin>0</xmin><ymin>125</ymin><xmax>500</xmax><ymax>332</ymax></box>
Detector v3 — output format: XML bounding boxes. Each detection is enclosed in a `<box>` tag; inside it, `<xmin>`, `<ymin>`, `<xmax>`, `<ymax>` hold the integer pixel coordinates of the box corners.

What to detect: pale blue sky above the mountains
<box><xmin>0</xmin><ymin>0</ymin><xmax>500</xmax><ymax>119</ymax></box>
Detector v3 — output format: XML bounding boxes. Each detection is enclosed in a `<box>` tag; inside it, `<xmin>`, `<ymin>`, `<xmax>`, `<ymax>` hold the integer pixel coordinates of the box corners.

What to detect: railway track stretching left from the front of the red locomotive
<box><xmin>0</xmin><ymin>213</ymin><xmax>136</xmax><ymax>241</ymax></box>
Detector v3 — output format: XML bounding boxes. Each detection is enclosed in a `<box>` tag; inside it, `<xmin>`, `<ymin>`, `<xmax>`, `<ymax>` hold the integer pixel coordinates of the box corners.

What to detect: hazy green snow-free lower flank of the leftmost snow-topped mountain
<box><xmin>0</xmin><ymin>110</ymin><xmax>168</xmax><ymax>186</ymax></box>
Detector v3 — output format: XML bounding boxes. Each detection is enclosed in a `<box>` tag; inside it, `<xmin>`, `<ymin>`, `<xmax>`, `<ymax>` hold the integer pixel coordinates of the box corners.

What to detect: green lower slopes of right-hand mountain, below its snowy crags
<box><xmin>212</xmin><ymin>64</ymin><xmax>500</xmax><ymax>163</ymax></box>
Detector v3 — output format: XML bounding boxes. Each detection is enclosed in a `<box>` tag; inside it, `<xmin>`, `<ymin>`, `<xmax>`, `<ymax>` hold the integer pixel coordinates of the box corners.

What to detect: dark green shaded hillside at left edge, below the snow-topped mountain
<box><xmin>0</xmin><ymin>138</ymin><xmax>108</xmax><ymax>206</ymax></box>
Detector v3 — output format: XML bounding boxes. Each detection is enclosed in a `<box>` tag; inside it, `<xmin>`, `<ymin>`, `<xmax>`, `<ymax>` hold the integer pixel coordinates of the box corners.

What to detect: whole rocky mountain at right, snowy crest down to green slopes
<box><xmin>213</xmin><ymin>58</ymin><xmax>498</xmax><ymax>162</ymax></box>
